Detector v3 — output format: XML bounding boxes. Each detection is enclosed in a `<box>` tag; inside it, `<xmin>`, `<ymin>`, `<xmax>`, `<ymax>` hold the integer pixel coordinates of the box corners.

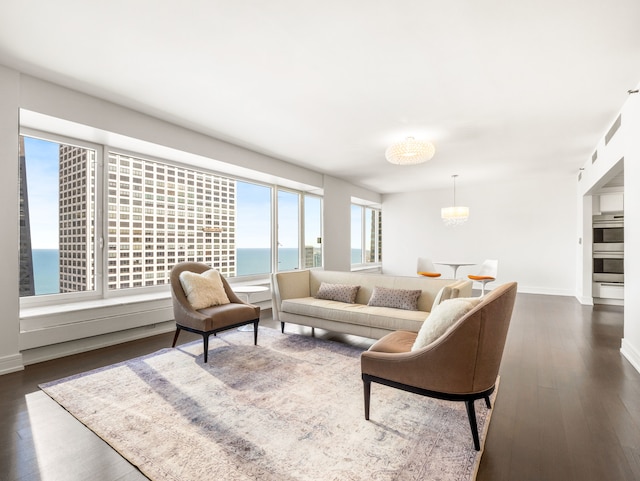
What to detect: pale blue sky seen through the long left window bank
<box><xmin>24</xmin><ymin>137</ymin><xmax>321</xmax><ymax>249</ymax></box>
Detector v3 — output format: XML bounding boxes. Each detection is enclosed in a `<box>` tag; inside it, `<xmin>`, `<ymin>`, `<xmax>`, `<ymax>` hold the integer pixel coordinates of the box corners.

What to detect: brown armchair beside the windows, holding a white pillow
<box><xmin>170</xmin><ymin>262</ymin><xmax>260</xmax><ymax>362</ymax></box>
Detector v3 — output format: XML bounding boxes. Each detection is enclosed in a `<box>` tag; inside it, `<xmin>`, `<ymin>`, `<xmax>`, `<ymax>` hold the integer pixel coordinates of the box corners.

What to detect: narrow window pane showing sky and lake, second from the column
<box><xmin>278</xmin><ymin>190</ymin><xmax>300</xmax><ymax>271</ymax></box>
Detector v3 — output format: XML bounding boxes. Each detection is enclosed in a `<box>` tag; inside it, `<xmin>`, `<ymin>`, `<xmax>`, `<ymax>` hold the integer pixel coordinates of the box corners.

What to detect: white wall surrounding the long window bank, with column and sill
<box><xmin>0</xmin><ymin>65</ymin><xmax>380</xmax><ymax>374</ymax></box>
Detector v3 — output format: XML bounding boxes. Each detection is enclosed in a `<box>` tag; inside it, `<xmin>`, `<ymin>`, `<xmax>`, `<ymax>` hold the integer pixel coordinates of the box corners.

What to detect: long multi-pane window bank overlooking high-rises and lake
<box><xmin>20</xmin><ymin>129</ymin><xmax>322</xmax><ymax>297</ymax></box>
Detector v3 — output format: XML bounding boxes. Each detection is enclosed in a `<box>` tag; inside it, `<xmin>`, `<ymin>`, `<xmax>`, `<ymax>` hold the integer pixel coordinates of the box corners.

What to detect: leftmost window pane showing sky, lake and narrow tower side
<box><xmin>19</xmin><ymin>136</ymin><xmax>96</xmax><ymax>297</ymax></box>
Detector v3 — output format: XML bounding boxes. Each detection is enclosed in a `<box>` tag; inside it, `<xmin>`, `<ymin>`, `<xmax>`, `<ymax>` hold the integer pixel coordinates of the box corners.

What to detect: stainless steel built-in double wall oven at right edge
<box><xmin>593</xmin><ymin>214</ymin><xmax>624</xmax><ymax>299</ymax></box>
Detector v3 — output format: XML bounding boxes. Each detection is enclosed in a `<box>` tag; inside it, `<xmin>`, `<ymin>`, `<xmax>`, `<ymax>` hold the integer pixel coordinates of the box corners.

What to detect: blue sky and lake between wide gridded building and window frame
<box><xmin>236</xmin><ymin>181</ymin><xmax>271</xmax><ymax>276</ymax></box>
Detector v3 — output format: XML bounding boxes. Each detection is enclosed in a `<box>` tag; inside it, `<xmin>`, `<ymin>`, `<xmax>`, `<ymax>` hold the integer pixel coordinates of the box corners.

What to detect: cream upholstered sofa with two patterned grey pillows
<box><xmin>272</xmin><ymin>270</ymin><xmax>473</xmax><ymax>339</ymax></box>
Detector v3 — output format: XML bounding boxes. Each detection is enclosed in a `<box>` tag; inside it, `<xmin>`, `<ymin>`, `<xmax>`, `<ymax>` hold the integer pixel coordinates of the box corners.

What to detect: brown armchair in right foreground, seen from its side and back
<box><xmin>360</xmin><ymin>282</ymin><xmax>517</xmax><ymax>450</ymax></box>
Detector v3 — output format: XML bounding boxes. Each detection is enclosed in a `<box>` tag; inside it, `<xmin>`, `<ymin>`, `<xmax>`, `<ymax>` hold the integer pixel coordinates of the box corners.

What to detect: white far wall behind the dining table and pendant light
<box><xmin>382</xmin><ymin>176</ymin><xmax>578</xmax><ymax>295</ymax></box>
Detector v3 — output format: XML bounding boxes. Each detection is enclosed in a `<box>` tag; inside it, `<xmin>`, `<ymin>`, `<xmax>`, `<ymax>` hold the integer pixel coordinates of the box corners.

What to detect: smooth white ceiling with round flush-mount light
<box><xmin>0</xmin><ymin>0</ymin><xmax>640</xmax><ymax>193</ymax></box>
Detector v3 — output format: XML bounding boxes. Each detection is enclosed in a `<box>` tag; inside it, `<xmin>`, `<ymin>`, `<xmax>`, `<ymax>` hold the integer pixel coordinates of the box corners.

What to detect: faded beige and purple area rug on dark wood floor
<box><xmin>40</xmin><ymin>328</ymin><xmax>495</xmax><ymax>481</ymax></box>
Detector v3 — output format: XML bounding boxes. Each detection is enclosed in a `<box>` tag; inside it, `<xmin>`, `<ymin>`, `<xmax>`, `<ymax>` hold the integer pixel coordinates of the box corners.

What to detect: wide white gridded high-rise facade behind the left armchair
<box><xmin>106</xmin><ymin>152</ymin><xmax>236</xmax><ymax>290</ymax></box>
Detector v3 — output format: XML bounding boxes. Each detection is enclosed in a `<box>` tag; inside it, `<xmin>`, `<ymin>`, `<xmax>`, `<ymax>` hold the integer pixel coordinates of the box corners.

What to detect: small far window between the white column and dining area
<box><xmin>351</xmin><ymin>204</ymin><xmax>382</xmax><ymax>265</ymax></box>
